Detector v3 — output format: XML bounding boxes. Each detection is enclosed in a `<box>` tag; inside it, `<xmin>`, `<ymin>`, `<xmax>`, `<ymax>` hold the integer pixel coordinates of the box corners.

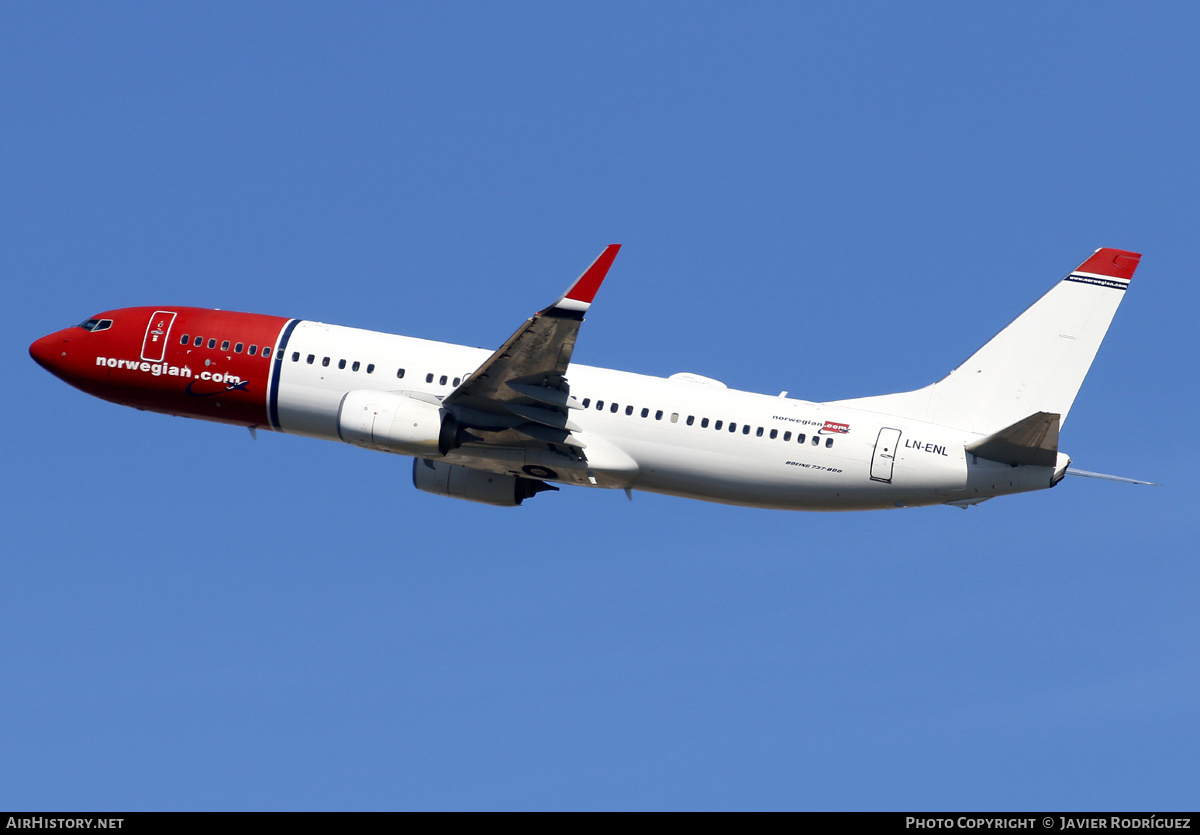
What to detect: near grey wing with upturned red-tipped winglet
<box><xmin>442</xmin><ymin>244</ymin><xmax>620</xmax><ymax>449</ymax></box>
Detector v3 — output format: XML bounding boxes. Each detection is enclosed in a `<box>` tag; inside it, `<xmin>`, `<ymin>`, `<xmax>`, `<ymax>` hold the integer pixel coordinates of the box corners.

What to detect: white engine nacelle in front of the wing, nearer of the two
<box><xmin>337</xmin><ymin>391</ymin><xmax>458</xmax><ymax>458</ymax></box>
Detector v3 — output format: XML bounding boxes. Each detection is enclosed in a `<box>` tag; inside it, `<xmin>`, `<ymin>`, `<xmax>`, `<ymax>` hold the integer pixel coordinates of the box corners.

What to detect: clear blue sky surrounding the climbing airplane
<box><xmin>7</xmin><ymin>2</ymin><xmax>1200</xmax><ymax>811</ymax></box>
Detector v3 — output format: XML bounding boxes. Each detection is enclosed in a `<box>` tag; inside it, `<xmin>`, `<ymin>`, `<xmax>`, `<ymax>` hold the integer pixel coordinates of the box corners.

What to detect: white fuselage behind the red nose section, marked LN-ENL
<box><xmin>276</xmin><ymin>322</ymin><xmax>1067</xmax><ymax>510</ymax></box>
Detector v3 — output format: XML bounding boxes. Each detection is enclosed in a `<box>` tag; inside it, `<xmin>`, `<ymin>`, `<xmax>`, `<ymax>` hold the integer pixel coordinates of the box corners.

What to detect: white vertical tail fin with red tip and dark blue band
<box><xmin>838</xmin><ymin>250</ymin><xmax>1141</xmax><ymax>434</ymax></box>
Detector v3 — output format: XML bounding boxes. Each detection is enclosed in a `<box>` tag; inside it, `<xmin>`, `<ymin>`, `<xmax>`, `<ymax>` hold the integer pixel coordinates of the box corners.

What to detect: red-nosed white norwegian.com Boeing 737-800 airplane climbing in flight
<box><xmin>29</xmin><ymin>244</ymin><xmax>1150</xmax><ymax>511</ymax></box>
